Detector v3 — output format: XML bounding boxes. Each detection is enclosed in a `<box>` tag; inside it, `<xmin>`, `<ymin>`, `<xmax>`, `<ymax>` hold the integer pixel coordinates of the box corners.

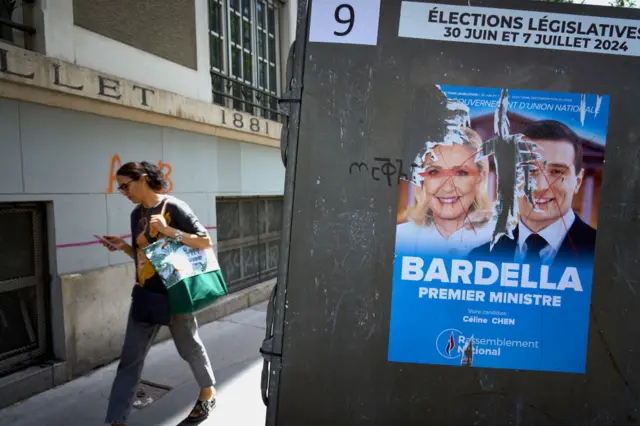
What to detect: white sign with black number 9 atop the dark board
<box><xmin>309</xmin><ymin>0</ymin><xmax>381</xmax><ymax>46</ymax></box>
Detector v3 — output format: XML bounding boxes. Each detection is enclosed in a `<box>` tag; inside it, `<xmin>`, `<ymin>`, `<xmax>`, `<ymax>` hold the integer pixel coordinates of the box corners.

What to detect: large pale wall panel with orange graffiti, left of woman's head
<box><xmin>20</xmin><ymin>102</ymin><xmax>162</xmax><ymax>194</ymax></box>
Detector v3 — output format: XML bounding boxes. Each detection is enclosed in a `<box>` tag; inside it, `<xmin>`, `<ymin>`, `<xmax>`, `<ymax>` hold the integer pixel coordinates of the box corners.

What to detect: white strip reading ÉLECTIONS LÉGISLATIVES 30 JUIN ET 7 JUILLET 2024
<box><xmin>398</xmin><ymin>1</ymin><xmax>640</xmax><ymax>56</ymax></box>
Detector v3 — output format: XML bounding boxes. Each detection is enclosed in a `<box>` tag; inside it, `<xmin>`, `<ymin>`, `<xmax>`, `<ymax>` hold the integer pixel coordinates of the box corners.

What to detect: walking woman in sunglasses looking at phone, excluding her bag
<box><xmin>103</xmin><ymin>161</ymin><xmax>216</xmax><ymax>425</ymax></box>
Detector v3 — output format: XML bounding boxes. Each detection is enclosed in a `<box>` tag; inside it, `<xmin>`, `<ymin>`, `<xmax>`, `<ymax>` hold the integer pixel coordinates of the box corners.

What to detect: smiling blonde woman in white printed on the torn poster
<box><xmin>396</xmin><ymin>127</ymin><xmax>495</xmax><ymax>256</ymax></box>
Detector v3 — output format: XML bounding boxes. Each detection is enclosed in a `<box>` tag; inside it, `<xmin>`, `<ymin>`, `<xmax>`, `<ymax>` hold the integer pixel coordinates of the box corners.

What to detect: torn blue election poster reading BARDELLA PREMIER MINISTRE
<box><xmin>388</xmin><ymin>85</ymin><xmax>609</xmax><ymax>373</ymax></box>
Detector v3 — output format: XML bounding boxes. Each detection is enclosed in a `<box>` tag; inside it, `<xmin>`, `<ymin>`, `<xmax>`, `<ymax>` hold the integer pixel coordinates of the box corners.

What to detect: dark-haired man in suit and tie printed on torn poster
<box><xmin>470</xmin><ymin>120</ymin><xmax>596</xmax><ymax>265</ymax></box>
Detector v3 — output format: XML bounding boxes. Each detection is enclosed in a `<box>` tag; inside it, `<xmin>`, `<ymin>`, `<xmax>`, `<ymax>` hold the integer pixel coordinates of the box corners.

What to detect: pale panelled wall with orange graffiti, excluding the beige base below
<box><xmin>0</xmin><ymin>99</ymin><xmax>284</xmax><ymax>274</ymax></box>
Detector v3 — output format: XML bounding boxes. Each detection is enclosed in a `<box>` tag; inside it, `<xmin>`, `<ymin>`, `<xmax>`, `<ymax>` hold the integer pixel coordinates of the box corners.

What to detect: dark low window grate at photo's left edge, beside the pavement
<box><xmin>0</xmin><ymin>204</ymin><xmax>48</xmax><ymax>374</ymax></box>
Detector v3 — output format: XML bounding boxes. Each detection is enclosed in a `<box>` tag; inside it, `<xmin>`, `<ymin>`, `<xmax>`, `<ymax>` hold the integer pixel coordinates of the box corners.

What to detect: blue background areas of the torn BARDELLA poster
<box><xmin>388</xmin><ymin>86</ymin><xmax>609</xmax><ymax>373</ymax></box>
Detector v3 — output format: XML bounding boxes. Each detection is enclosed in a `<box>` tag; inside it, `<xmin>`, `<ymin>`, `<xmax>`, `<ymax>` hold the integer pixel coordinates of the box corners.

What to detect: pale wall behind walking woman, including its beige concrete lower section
<box><xmin>0</xmin><ymin>98</ymin><xmax>284</xmax><ymax>377</ymax></box>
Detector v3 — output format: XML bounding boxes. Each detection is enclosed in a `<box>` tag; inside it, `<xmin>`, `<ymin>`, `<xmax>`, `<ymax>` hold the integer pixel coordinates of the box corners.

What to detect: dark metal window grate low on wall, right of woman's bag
<box><xmin>216</xmin><ymin>197</ymin><xmax>282</xmax><ymax>292</ymax></box>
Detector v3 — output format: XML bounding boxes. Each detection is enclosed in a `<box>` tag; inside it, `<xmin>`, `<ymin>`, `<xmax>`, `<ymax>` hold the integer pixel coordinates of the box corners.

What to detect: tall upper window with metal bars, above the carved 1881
<box><xmin>209</xmin><ymin>0</ymin><xmax>280</xmax><ymax>120</ymax></box>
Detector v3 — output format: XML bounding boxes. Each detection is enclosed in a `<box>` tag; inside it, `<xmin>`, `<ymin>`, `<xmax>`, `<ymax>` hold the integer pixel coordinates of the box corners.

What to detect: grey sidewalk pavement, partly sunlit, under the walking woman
<box><xmin>0</xmin><ymin>302</ymin><xmax>267</xmax><ymax>426</ymax></box>
